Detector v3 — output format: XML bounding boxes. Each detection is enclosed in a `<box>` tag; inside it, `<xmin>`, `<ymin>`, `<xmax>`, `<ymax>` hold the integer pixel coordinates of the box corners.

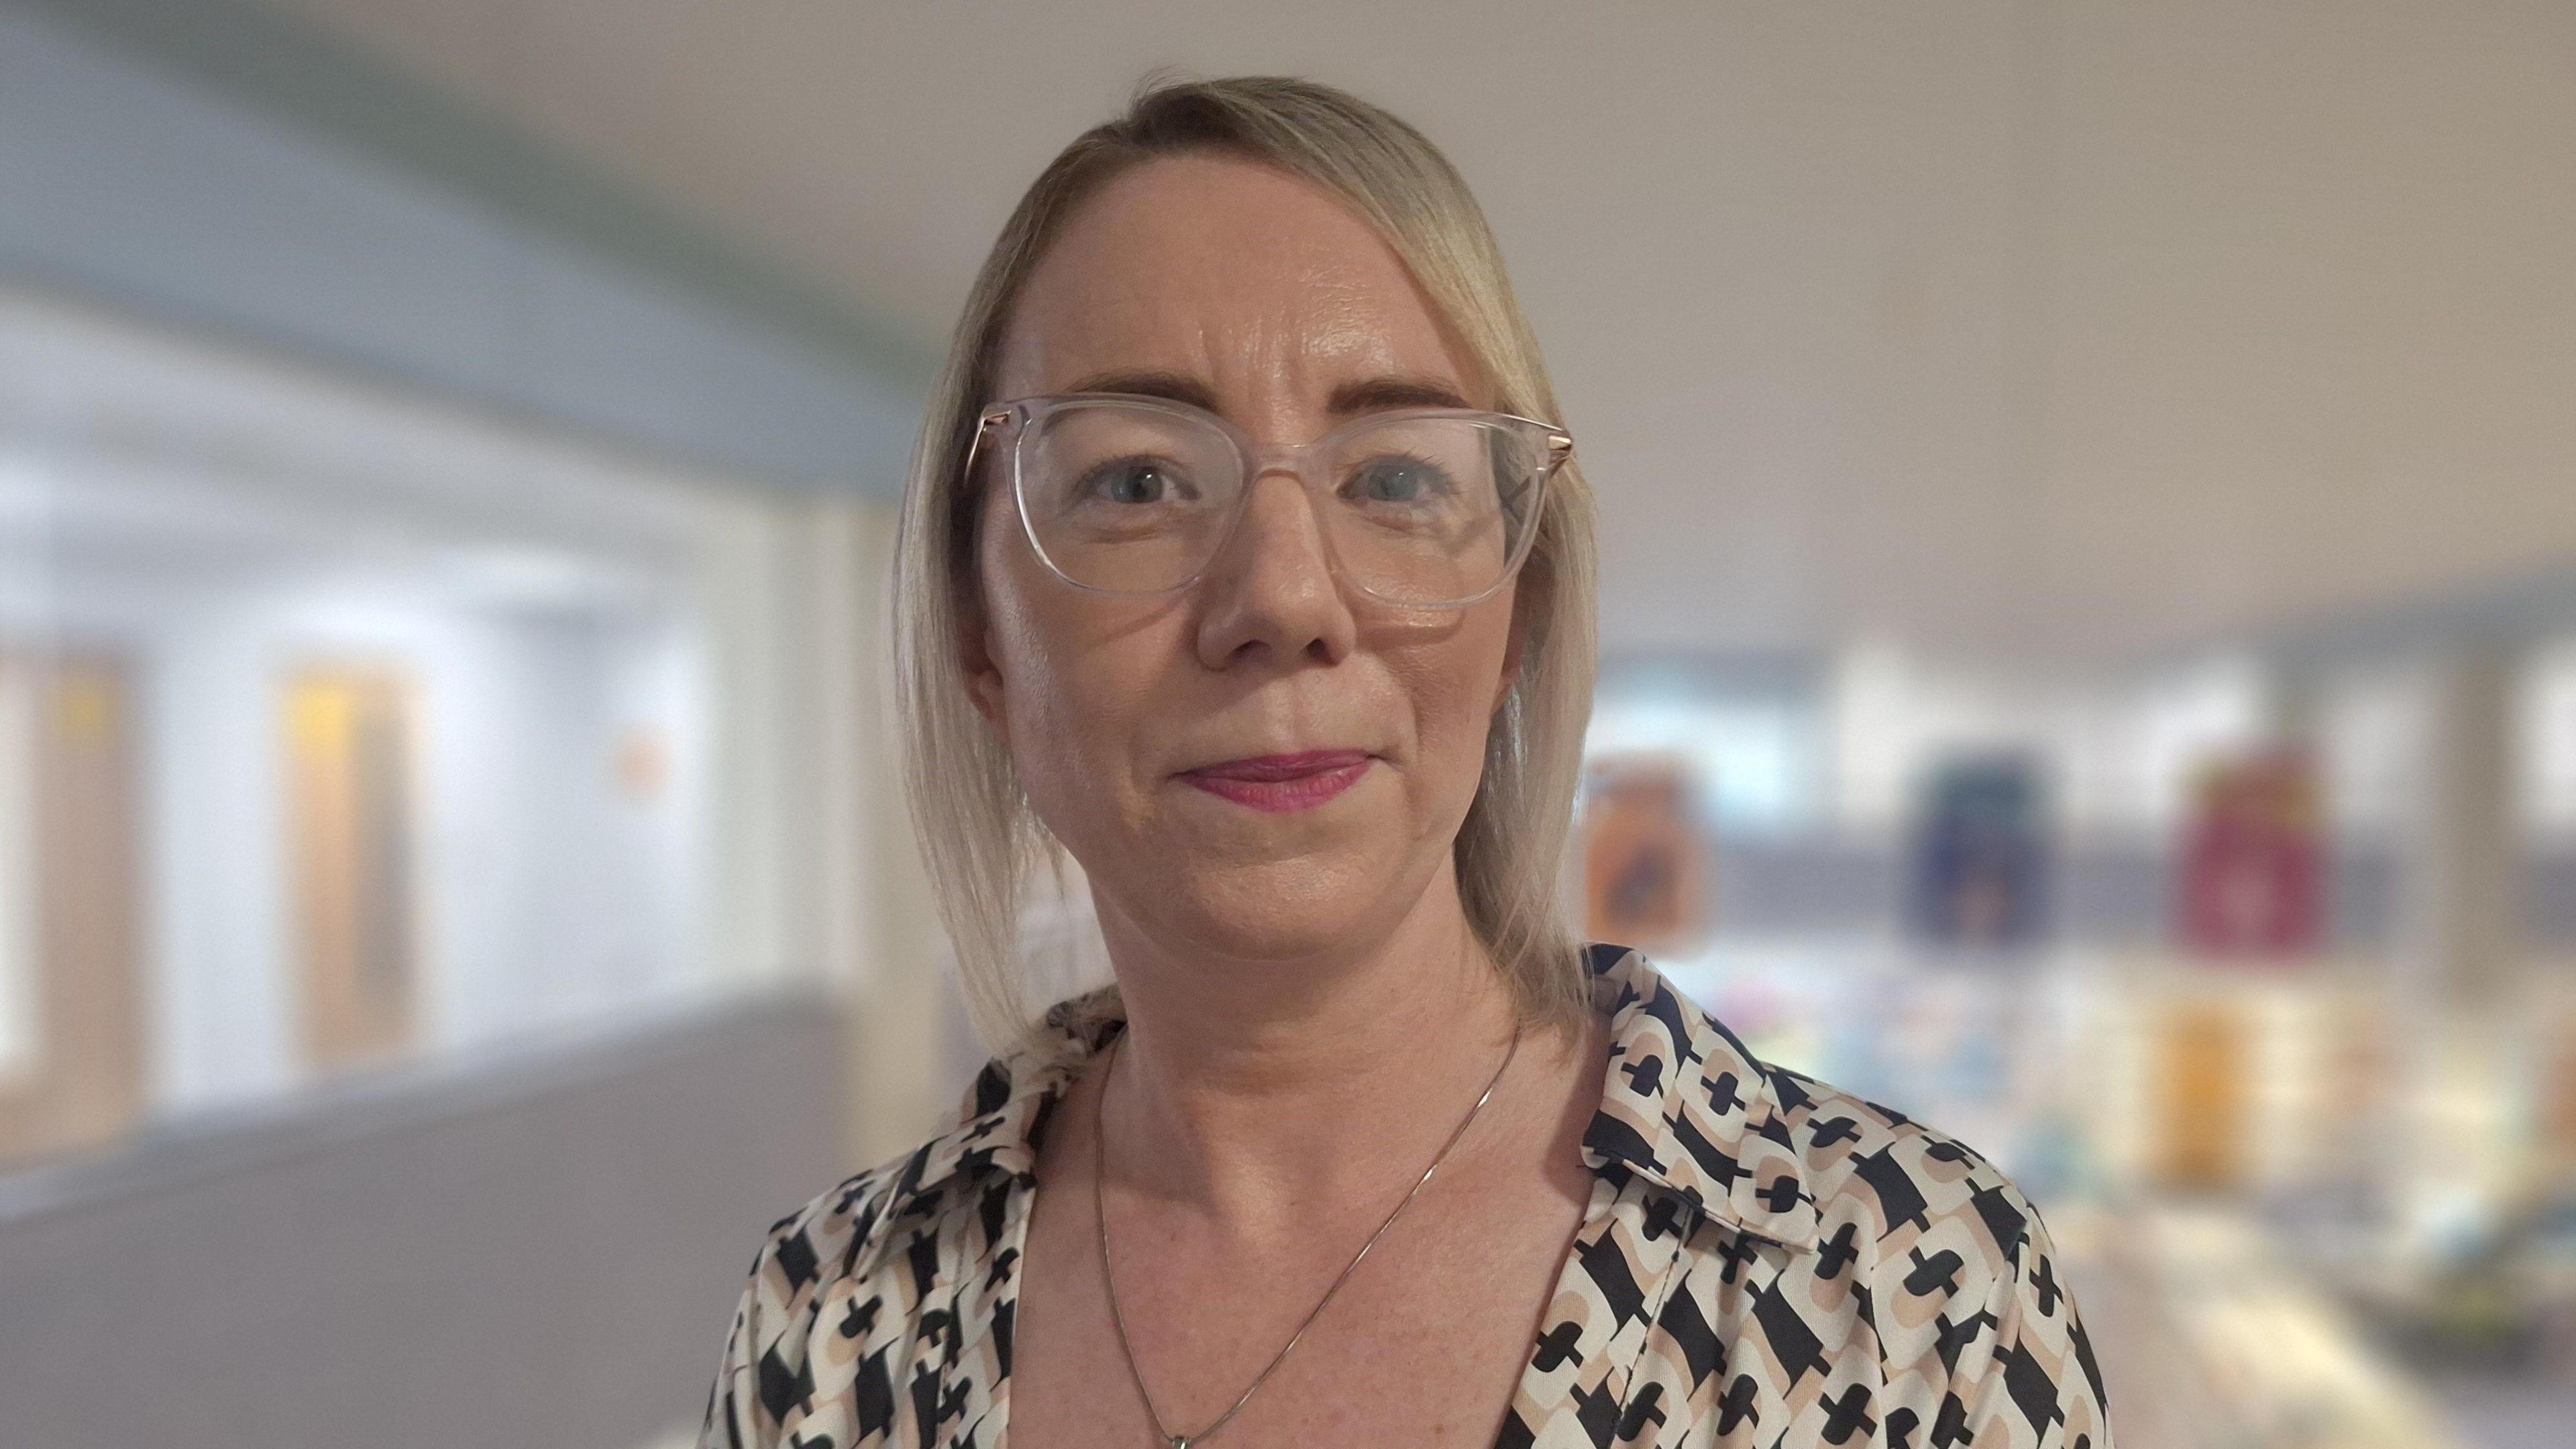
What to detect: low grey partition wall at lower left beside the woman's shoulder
<box><xmin>0</xmin><ymin>996</ymin><xmax>853</xmax><ymax>1449</ymax></box>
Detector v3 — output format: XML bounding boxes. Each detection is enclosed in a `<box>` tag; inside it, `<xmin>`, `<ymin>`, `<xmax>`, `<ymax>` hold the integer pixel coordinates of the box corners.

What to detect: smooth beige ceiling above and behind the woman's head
<box><xmin>241</xmin><ymin>0</ymin><xmax>2576</xmax><ymax>657</ymax></box>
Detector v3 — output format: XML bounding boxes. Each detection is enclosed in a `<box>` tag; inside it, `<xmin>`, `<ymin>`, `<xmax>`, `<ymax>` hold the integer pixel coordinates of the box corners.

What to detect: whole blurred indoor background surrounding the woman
<box><xmin>0</xmin><ymin>0</ymin><xmax>2576</xmax><ymax>1449</ymax></box>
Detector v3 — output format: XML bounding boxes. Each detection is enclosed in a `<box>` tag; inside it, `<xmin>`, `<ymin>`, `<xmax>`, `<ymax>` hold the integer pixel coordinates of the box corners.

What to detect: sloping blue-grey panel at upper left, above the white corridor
<box><xmin>0</xmin><ymin>5</ymin><xmax>920</xmax><ymax>495</ymax></box>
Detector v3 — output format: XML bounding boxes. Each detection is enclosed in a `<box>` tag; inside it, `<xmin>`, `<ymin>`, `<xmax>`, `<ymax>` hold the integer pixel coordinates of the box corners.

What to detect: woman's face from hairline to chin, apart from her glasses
<box><xmin>966</xmin><ymin>157</ymin><xmax>1517</xmax><ymax>959</ymax></box>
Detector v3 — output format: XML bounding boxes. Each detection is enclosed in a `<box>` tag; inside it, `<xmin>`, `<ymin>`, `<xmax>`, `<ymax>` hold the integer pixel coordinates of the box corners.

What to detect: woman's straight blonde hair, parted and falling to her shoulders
<box><xmin>894</xmin><ymin>74</ymin><xmax>1595</xmax><ymax>1052</ymax></box>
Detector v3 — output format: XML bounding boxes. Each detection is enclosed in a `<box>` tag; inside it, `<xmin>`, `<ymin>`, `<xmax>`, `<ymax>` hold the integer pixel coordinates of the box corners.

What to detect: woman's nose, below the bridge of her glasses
<box><xmin>1198</xmin><ymin>470</ymin><xmax>1358</xmax><ymax>670</ymax></box>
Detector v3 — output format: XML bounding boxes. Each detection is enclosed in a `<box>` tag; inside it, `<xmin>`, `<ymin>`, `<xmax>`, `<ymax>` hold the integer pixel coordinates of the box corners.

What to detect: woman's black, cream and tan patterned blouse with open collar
<box><xmin>698</xmin><ymin>947</ymin><xmax>2110</xmax><ymax>1449</ymax></box>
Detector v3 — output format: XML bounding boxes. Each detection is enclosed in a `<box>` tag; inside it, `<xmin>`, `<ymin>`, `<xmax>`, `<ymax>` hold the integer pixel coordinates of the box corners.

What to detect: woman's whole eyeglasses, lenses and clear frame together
<box><xmin>966</xmin><ymin>392</ymin><xmax>1574</xmax><ymax>608</ymax></box>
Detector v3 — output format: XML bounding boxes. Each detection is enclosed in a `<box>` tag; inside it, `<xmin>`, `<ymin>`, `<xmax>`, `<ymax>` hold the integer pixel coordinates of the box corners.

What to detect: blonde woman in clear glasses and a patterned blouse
<box><xmin>703</xmin><ymin>80</ymin><xmax>2110</xmax><ymax>1449</ymax></box>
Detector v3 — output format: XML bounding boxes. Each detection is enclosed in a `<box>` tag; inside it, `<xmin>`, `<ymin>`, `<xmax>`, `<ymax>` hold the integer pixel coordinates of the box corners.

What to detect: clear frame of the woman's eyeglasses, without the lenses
<box><xmin>963</xmin><ymin>392</ymin><xmax>1574</xmax><ymax>608</ymax></box>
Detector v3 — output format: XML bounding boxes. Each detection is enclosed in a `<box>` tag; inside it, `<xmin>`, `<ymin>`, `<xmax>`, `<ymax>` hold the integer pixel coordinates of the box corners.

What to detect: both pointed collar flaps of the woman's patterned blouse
<box><xmin>868</xmin><ymin>944</ymin><xmax>1816</xmax><ymax>1256</ymax></box>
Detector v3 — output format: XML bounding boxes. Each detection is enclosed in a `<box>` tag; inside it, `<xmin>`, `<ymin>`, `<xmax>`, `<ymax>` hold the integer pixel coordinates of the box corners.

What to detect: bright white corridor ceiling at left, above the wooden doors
<box><xmin>0</xmin><ymin>288</ymin><xmax>721</xmax><ymax>619</ymax></box>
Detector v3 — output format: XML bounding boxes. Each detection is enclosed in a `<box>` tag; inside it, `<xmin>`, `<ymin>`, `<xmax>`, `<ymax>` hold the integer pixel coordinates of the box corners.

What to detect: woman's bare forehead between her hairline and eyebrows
<box><xmin>994</xmin><ymin>157</ymin><xmax>1476</xmax><ymax>407</ymax></box>
